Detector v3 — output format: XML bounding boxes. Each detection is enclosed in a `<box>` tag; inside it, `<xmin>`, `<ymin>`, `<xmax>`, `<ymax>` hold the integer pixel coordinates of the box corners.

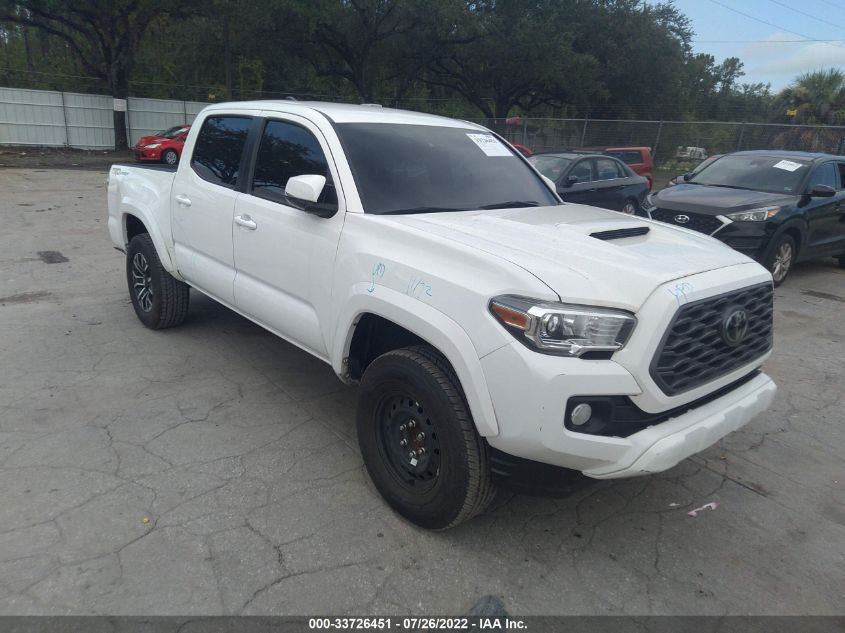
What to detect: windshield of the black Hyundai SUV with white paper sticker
<box><xmin>687</xmin><ymin>156</ymin><xmax>810</xmax><ymax>193</ymax></box>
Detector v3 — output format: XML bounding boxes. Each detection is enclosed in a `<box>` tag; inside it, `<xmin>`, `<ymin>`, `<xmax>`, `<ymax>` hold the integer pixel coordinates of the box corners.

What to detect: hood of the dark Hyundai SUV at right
<box><xmin>651</xmin><ymin>183</ymin><xmax>798</xmax><ymax>215</ymax></box>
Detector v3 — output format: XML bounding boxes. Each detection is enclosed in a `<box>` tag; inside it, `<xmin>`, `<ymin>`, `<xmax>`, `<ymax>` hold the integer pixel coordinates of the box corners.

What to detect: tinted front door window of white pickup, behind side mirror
<box><xmin>252</xmin><ymin>121</ymin><xmax>337</xmax><ymax>209</ymax></box>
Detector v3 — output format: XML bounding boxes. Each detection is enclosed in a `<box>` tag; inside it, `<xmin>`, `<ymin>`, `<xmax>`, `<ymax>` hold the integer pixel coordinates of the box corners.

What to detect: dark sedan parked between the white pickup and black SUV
<box><xmin>528</xmin><ymin>152</ymin><xmax>648</xmax><ymax>215</ymax></box>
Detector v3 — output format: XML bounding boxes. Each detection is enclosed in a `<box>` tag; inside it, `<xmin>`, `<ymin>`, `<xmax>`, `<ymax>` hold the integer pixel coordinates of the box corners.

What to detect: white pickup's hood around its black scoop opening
<box><xmin>378</xmin><ymin>204</ymin><xmax>751</xmax><ymax>310</ymax></box>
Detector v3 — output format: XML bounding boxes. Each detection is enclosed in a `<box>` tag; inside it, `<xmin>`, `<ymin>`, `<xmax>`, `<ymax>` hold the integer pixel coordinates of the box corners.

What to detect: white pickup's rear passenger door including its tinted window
<box><xmin>170</xmin><ymin>114</ymin><xmax>253</xmax><ymax>304</ymax></box>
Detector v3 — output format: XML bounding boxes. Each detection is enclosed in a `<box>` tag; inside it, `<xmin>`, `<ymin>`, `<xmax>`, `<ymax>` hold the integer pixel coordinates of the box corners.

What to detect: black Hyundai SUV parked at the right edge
<box><xmin>646</xmin><ymin>150</ymin><xmax>845</xmax><ymax>285</ymax></box>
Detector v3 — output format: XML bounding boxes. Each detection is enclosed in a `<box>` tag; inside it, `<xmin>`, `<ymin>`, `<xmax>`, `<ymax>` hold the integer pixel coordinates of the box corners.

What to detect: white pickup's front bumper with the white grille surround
<box><xmin>481</xmin><ymin>262</ymin><xmax>776</xmax><ymax>478</ymax></box>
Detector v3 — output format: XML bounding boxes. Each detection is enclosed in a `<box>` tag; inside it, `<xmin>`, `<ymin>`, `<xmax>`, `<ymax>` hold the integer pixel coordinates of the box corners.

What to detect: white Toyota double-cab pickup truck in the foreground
<box><xmin>108</xmin><ymin>101</ymin><xmax>775</xmax><ymax>529</ymax></box>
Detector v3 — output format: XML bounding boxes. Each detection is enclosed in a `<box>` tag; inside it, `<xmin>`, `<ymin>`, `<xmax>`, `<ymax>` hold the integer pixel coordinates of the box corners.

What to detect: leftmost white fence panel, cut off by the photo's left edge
<box><xmin>0</xmin><ymin>88</ymin><xmax>67</xmax><ymax>146</ymax></box>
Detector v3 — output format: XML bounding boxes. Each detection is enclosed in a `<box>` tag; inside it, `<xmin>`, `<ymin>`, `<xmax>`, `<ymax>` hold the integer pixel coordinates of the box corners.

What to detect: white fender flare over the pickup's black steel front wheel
<box><xmin>331</xmin><ymin>283</ymin><xmax>499</xmax><ymax>437</ymax></box>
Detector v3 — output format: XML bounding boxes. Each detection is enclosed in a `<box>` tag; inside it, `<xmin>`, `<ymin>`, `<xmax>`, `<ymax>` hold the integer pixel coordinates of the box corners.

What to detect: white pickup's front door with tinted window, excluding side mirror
<box><xmin>234</xmin><ymin>115</ymin><xmax>345</xmax><ymax>358</ymax></box>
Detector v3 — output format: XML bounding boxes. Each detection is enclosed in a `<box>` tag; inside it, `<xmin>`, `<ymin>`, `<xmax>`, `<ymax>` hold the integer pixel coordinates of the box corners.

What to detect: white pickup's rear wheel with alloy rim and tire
<box><xmin>126</xmin><ymin>233</ymin><xmax>190</xmax><ymax>330</ymax></box>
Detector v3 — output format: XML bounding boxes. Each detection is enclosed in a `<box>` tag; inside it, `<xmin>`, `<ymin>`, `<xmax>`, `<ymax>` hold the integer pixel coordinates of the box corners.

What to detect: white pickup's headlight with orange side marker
<box><xmin>490</xmin><ymin>295</ymin><xmax>637</xmax><ymax>356</ymax></box>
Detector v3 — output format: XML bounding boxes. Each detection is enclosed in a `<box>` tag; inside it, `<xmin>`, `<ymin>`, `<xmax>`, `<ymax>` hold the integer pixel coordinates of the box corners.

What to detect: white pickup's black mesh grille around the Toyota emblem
<box><xmin>650</xmin><ymin>283</ymin><xmax>772</xmax><ymax>396</ymax></box>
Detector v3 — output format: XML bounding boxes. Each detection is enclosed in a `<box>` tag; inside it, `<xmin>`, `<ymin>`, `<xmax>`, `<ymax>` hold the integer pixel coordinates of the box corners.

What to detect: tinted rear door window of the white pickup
<box><xmin>191</xmin><ymin>116</ymin><xmax>252</xmax><ymax>189</ymax></box>
